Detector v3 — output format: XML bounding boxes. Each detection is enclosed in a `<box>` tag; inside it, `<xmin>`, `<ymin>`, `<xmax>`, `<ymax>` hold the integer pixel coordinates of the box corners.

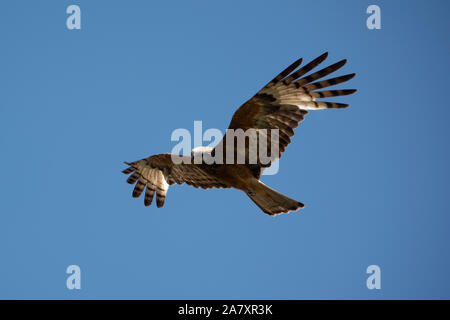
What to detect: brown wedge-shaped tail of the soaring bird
<box><xmin>246</xmin><ymin>179</ymin><xmax>305</xmax><ymax>216</ymax></box>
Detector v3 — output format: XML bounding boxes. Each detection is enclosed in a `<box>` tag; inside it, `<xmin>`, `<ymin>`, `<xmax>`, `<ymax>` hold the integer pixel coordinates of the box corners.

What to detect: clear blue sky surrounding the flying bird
<box><xmin>0</xmin><ymin>0</ymin><xmax>450</xmax><ymax>299</ymax></box>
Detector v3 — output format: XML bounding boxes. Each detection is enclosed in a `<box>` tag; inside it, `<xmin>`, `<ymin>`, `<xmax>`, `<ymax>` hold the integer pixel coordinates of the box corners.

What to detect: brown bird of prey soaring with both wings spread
<box><xmin>122</xmin><ymin>53</ymin><xmax>356</xmax><ymax>216</ymax></box>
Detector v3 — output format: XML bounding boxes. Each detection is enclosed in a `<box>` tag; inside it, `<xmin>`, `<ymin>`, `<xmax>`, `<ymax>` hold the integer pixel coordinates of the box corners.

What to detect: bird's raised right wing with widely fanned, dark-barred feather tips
<box><xmin>214</xmin><ymin>53</ymin><xmax>356</xmax><ymax>174</ymax></box>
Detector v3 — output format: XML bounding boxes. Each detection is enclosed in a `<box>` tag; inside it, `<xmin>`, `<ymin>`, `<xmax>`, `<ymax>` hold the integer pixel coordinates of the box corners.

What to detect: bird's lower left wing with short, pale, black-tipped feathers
<box><xmin>122</xmin><ymin>153</ymin><xmax>229</xmax><ymax>208</ymax></box>
